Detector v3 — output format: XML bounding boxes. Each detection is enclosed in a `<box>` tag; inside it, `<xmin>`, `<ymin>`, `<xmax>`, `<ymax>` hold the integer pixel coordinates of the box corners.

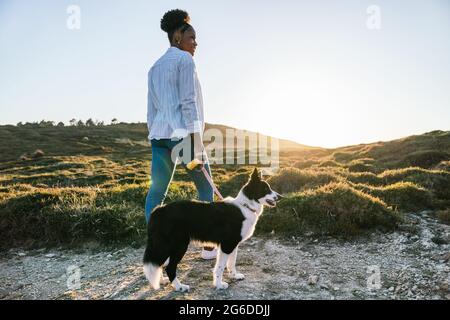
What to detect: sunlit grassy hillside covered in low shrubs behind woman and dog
<box><xmin>0</xmin><ymin>123</ymin><xmax>450</xmax><ymax>249</ymax></box>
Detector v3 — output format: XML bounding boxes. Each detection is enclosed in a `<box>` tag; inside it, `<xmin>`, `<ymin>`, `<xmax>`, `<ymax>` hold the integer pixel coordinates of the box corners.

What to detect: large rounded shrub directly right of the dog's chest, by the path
<box><xmin>257</xmin><ymin>183</ymin><xmax>401</xmax><ymax>236</ymax></box>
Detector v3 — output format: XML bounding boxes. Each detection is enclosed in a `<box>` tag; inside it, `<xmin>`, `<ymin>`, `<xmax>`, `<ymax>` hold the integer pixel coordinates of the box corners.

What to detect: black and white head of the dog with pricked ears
<box><xmin>242</xmin><ymin>168</ymin><xmax>283</xmax><ymax>207</ymax></box>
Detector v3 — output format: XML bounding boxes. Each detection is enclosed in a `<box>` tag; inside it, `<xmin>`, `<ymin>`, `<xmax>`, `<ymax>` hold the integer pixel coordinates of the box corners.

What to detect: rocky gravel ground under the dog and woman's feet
<box><xmin>0</xmin><ymin>212</ymin><xmax>450</xmax><ymax>300</ymax></box>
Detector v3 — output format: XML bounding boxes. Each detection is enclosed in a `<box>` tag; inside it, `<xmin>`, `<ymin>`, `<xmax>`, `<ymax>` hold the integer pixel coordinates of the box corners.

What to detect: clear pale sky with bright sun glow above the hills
<box><xmin>0</xmin><ymin>0</ymin><xmax>450</xmax><ymax>147</ymax></box>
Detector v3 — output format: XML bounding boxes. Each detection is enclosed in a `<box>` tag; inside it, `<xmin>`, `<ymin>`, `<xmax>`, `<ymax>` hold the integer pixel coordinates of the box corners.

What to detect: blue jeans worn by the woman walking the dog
<box><xmin>145</xmin><ymin>139</ymin><xmax>214</xmax><ymax>223</ymax></box>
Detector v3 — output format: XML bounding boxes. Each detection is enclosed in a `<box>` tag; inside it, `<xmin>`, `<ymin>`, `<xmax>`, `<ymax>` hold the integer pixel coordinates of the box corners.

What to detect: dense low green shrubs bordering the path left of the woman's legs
<box><xmin>0</xmin><ymin>183</ymin><xmax>196</xmax><ymax>249</ymax></box>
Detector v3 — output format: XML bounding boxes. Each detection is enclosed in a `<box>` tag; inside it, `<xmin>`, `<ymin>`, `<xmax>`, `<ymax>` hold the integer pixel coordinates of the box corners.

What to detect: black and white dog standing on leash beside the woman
<box><xmin>144</xmin><ymin>168</ymin><xmax>282</xmax><ymax>291</ymax></box>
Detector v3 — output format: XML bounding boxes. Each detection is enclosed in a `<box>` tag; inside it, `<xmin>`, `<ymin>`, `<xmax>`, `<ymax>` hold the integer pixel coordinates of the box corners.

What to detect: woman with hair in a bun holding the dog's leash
<box><xmin>145</xmin><ymin>9</ymin><xmax>217</xmax><ymax>259</ymax></box>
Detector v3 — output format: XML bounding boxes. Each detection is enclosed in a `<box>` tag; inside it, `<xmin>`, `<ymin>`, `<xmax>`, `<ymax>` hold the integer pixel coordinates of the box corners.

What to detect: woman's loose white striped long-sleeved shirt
<box><xmin>147</xmin><ymin>47</ymin><xmax>205</xmax><ymax>140</ymax></box>
